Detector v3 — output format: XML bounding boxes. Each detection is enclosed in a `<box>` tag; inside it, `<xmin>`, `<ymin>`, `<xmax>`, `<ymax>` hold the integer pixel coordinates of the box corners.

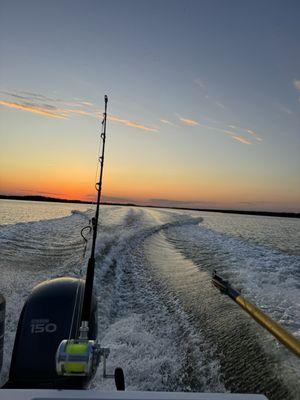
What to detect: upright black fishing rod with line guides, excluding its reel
<box><xmin>80</xmin><ymin>95</ymin><xmax>108</xmax><ymax>328</ymax></box>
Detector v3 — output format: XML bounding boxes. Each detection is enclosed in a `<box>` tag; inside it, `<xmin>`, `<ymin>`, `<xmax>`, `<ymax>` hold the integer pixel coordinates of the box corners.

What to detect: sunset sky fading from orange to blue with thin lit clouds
<box><xmin>0</xmin><ymin>0</ymin><xmax>300</xmax><ymax>212</ymax></box>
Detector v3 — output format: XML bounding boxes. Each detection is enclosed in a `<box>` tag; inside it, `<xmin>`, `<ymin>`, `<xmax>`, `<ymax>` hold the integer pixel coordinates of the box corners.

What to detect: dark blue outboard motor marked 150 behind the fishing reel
<box><xmin>5</xmin><ymin>278</ymin><xmax>97</xmax><ymax>389</ymax></box>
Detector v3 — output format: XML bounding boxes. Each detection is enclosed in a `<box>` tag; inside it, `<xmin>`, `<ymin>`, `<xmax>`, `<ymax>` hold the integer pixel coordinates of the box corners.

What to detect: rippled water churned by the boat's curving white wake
<box><xmin>0</xmin><ymin>202</ymin><xmax>300</xmax><ymax>399</ymax></box>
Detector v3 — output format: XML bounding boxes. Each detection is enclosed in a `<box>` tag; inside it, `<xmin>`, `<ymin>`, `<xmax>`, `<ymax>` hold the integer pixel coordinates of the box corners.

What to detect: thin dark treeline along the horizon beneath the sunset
<box><xmin>0</xmin><ymin>194</ymin><xmax>300</xmax><ymax>218</ymax></box>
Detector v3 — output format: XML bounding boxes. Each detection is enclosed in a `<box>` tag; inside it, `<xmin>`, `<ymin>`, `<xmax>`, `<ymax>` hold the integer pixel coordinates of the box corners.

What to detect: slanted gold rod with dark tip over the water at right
<box><xmin>212</xmin><ymin>271</ymin><xmax>300</xmax><ymax>357</ymax></box>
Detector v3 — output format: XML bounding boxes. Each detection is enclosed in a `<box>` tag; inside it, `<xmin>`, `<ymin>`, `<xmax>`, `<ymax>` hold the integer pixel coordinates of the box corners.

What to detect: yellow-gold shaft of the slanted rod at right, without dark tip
<box><xmin>234</xmin><ymin>296</ymin><xmax>300</xmax><ymax>357</ymax></box>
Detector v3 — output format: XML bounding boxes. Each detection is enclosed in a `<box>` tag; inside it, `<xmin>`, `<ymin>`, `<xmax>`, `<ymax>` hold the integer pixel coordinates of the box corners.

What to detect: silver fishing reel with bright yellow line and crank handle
<box><xmin>55</xmin><ymin>339</ymin><xmax>125</xmax><ymax>390</ymax></box>
